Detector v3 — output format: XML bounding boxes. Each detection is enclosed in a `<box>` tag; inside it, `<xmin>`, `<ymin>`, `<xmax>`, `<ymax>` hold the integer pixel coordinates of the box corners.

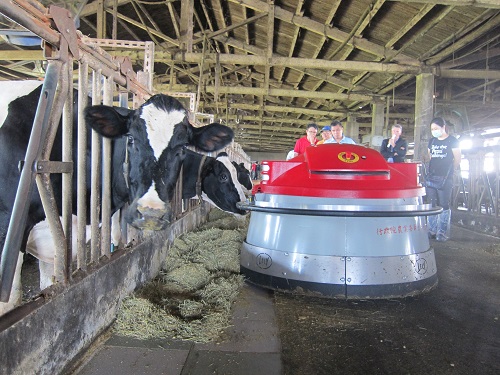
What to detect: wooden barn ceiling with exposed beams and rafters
<box><xmin>0</xmin><ymin>0</ymin><xmax>500</xmax><ymax>152</ymax></box>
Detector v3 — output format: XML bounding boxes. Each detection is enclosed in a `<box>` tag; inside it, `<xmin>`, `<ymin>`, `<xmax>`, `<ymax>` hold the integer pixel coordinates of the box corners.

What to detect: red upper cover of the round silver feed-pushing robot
<box><xmin>253</xmin><ymin>144</ymin><xmax>425</xmax><ymax>199</ymax></box>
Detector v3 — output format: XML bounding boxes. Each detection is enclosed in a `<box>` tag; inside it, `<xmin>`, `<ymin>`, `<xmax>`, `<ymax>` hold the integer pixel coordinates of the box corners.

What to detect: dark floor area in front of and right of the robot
<box><xmin>275</xmin><ymin>227</ymin><xmax>500</xmax><ymax>375</ymax></box>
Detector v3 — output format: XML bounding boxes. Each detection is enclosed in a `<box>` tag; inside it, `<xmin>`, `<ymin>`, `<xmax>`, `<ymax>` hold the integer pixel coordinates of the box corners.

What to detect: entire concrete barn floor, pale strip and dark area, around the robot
<box><xmin>72</xmin><ymin>227</ymin><xmax>500</xmax><ymax>375</ymax></box>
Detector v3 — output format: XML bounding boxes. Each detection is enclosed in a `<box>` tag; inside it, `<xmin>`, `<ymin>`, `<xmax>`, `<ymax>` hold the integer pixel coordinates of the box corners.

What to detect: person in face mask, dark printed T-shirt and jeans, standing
<box><xmin>425</xmin><ymin>117</ymin><xmax>462</xmax><ymax>241</ymax></box>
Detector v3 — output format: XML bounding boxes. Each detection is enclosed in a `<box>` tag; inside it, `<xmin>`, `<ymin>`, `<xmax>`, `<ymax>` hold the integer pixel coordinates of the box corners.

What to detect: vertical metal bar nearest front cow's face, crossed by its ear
<box><xmin>101</xmin><ymin>77</ymin><xmax>115</xmax><ymax>258</ymax></box>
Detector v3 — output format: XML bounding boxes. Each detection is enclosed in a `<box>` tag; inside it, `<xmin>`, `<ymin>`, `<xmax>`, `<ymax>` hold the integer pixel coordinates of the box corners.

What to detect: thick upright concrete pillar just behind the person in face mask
<box><xmin>413</xmin><ymin>73</ymin><xmax>434</xmax><ymax>161</ymax></box>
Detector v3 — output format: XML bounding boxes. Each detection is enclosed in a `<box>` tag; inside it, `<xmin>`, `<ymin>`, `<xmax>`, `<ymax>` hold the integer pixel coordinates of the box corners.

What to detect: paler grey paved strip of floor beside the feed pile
<box><xmin>73</xmin><ymin>284</ymin><xmax>282</xmax><ymax>375</ymax></box>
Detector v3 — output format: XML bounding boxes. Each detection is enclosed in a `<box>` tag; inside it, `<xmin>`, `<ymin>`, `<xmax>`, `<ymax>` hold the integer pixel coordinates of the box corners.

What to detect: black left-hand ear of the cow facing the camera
<box><xmin>85</xmin><ymin>105</ymin><xmax>133</xmax><ymax>138</ymax></box>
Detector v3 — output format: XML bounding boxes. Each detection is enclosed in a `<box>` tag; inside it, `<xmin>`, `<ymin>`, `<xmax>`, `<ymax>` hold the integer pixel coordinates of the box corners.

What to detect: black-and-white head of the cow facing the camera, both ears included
<box><xmin>85</xmin><ymin>94</ymin><xmax>233</xmax><ymax>229</ymax></box>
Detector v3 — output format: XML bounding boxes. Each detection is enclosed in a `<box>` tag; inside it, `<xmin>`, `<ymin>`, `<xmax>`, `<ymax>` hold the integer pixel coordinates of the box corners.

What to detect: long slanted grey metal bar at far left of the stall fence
<box><xmin>0</xmin><ymin>61</ymin><xmax>61</xmax><ymax>302</ymax></box>
